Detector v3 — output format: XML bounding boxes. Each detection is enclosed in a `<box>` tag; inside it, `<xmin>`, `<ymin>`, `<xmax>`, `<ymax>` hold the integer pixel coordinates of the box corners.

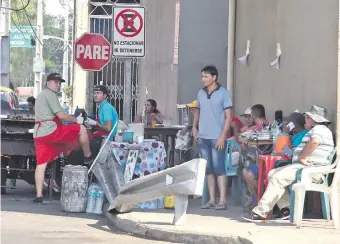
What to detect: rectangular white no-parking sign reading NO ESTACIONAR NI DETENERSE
<box><xmin>112</xmin><ymin>7</ymin><xmax>145</xmax><ymax>57</ymax></box>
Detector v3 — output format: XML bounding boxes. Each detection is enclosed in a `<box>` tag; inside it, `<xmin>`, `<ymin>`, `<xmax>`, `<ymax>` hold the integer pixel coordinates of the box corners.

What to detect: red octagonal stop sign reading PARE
<box><xmin>73</xmin><ymin>33</ymin><xmax>112</xmax><ymax>71</ymax></box>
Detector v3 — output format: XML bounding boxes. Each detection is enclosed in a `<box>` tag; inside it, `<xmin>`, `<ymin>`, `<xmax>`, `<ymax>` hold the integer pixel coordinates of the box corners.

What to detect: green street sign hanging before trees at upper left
<box><xmin>9</xmin><ymin>26</ymin><xmax>37</xmax><ymax>48</ymax></box>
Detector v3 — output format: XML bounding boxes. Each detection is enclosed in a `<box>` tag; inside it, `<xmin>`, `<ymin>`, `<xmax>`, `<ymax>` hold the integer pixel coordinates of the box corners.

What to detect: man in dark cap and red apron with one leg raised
<box><xmin>33</xmin><ymin>73</ymin><xmax>92</xmax><ymax>203</ymax></box>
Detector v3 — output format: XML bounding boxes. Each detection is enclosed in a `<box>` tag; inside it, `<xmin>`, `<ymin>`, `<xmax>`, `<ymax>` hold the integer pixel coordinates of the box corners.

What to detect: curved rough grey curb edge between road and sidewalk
<box><xmin>105</xmin><ymin>212</ymin><xmax>253</xmax><ymax>244</ymax></box>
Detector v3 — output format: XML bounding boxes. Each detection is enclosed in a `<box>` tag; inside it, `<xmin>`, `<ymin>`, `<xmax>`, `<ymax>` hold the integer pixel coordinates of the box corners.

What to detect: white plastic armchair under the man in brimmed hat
<box><xmin>293</xmin><ymin>159</ymin><xmax>340</xmax><ymax>229</ymax></box>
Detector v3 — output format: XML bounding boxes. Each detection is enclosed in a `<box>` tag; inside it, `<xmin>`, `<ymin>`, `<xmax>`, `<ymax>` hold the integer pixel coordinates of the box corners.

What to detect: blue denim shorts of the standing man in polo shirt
<box><xmin>198</xmin><ymin>138</ymin><xmax>225</xmax><ymax>176</ymax></box>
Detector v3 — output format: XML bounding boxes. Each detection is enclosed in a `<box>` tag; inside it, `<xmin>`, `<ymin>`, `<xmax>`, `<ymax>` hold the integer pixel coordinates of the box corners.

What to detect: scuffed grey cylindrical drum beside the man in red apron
<box><xmin>60</xmin><ymin>165</ymin><xmax>88</xmax><ymax>213</ymax></box>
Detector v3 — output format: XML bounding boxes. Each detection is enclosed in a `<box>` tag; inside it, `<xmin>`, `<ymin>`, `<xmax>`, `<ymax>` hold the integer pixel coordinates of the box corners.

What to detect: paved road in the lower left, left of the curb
<box><xmin>1</xmin><ymin>182</ymin><xmax>170</xmax><ymax>244</ymax></box>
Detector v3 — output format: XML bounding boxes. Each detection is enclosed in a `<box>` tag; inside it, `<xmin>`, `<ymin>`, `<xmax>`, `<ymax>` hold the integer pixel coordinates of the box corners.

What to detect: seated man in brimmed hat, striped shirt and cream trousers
<box><xmin>242</xmin><ymin>105</ymin><xmax>334</xmax><ymax>222</ymax></box>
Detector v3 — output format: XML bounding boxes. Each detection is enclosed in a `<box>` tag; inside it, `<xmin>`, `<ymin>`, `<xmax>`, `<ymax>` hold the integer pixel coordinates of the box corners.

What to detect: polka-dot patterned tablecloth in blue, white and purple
<box><xmin>111</xmin><ymin>141</ymin><xmax>166</xmax><ymax>179</ymax></box>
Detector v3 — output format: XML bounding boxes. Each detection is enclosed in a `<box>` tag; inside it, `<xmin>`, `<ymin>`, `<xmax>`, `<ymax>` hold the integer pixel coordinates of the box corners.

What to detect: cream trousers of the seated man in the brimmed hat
<box><xmin>253</xmin><ymin>164</ymin><xmax>305</xmax><ymax>218</ymax></box>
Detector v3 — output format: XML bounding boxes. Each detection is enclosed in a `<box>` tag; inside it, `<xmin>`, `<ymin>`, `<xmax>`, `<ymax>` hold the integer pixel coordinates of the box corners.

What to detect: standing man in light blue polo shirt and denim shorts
<box><xmin>193</xmin><ymin>66</ymin><xmax>232</xmax><ymax>210</ymax></box>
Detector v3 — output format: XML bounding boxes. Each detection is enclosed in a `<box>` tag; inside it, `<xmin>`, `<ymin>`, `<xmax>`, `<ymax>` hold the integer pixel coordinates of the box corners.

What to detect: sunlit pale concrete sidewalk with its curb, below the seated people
<box><xmin>106</xmin><ymin>200</ymin><xmax>340</xmax><ymax>244</ymax></box>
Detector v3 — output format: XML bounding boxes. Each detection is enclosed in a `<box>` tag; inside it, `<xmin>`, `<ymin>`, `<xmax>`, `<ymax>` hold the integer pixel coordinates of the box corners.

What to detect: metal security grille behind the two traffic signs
<box><xmin>89</xmin><ymin>1</ymin><xmax>139</xmax><ymax>123</ymax></box>
